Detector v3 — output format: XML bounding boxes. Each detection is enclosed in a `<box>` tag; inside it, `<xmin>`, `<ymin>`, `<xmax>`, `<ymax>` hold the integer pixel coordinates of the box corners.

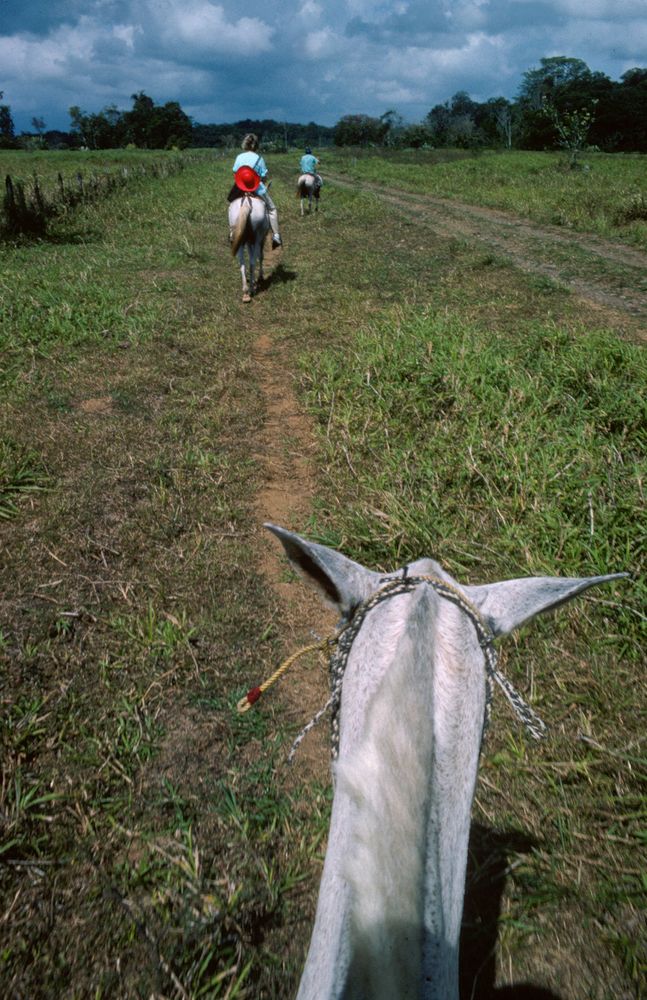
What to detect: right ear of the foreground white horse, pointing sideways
<box><xmin>462</xmin><ymin>573</ymin><xmax>629</xmax><ymax>635</ymax></box>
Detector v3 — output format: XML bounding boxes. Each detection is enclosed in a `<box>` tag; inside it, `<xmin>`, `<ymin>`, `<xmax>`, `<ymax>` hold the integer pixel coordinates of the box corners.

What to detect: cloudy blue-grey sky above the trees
<box><xmin>0</xmin><ymin>0</ymin><xmax>647</xmax><ymax>132</ymax></box>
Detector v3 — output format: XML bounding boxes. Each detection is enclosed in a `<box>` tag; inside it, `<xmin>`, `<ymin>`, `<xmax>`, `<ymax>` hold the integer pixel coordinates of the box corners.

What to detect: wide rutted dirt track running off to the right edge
<box><xmin>327</xmin><ymin>175</ymin><xmax>647</xmax><ymax>341</ymax></box>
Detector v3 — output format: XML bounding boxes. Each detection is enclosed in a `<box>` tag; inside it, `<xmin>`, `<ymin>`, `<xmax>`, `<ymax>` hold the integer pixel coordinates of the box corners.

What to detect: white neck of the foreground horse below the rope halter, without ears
<box><xmin>299</xmin><ymin>588</ymin><xmax>484</xmax><ymax>1000</ymax></box>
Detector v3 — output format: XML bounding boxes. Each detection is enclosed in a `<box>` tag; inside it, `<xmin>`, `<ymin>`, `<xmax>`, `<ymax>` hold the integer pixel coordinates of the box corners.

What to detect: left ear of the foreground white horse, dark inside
<box><xmin>265</xmin><ymin>524</ymin><xmax>380</xmax><ymax>618</ymax></box>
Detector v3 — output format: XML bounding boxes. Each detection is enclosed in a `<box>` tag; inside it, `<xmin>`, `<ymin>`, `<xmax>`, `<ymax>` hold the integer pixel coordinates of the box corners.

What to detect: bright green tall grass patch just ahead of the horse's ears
<box><xmin>308</xmin><ymin>315</ymin><xmax>647</xmax><ymax>632</ymax></box>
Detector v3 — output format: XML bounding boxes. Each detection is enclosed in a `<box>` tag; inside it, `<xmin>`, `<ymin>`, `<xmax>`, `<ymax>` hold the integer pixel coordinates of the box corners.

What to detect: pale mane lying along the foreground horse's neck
<box><xmin>336</xmin><ymin>592</ymin><xmax>433</xmax><ymax>1000</ymax></box>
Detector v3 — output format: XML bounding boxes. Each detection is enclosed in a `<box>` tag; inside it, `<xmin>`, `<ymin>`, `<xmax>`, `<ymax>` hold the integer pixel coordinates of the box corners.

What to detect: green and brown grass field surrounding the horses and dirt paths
<box><xmin>0</xmin><ymin>148</ymin><xmax>647</xmax><ymax>1000</ymax></box>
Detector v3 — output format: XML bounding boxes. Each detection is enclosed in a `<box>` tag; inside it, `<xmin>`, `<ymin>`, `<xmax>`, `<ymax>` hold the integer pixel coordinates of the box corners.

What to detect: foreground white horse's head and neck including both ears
<box><xmin>267</xmin><ymin>525</ymin><xmax>626</xmax><ymax>1000</ymax></box>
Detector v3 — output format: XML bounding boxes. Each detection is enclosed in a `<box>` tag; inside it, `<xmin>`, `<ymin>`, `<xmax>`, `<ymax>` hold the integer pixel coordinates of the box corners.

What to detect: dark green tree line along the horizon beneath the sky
<box><xmin>0</xmin><ymin>56</ymin><xmax>647</xmax><ymax>154</ymax></box>
